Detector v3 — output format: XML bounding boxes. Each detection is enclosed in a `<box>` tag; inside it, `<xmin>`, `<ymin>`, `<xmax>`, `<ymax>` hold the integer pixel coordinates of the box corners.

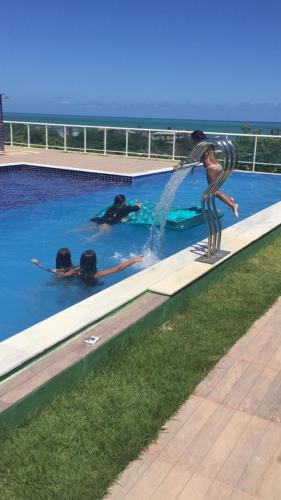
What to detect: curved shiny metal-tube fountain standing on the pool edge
<box><xmin>178</xmin><ymin>138</ymin><xmax>237</xmax><ymax>264</ymax></box>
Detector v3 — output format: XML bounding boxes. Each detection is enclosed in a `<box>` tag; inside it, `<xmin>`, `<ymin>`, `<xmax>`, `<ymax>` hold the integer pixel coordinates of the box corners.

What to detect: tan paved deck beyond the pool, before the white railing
<box><xmin>0</xmin><ymin>147</ymin><xmax>177</xmax><ymax>177</ymax></box>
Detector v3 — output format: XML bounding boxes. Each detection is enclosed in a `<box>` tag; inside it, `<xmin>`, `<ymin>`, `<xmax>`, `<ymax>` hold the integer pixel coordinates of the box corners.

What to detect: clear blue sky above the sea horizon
<box><xmin>0</xmin><ymin>0</ymin><xmax>281</xmax><ymax>121</ymax></box>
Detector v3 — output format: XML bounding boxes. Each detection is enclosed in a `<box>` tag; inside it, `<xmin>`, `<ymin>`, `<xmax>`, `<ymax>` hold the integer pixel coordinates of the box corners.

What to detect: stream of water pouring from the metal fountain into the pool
<box><xmin>143</xmin><ymin>166</ymin><xmax>192</xmax><ymax>263</ymax></box>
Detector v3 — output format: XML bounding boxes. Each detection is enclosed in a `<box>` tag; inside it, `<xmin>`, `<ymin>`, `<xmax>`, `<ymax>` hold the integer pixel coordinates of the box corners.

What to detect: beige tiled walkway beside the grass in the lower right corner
<box><xmin>107</xmin><ymin>298</ymin><xmax>281</xmax><ymax>500</ymax></box>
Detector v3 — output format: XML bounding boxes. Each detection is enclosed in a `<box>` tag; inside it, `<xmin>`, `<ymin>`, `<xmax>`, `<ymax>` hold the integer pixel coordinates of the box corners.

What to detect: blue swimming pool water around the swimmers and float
<box><xmin>0</xmin><ymin>169</ymin><xmax>281</xmax><ymax>340</ymax></box>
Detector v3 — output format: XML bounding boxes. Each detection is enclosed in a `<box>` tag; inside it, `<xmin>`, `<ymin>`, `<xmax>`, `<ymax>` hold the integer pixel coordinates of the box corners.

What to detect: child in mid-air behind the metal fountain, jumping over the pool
<box><xmin>191</xmin><ymin>130</ymin><xmax>239</xmax><ymax>217</ymax></box>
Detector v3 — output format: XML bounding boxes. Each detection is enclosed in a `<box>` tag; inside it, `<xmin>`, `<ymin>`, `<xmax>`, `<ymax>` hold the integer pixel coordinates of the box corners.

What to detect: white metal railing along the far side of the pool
<box><xmin>4</xmin><ymin>120</ymin><xmax>281</xmax><ymax>173</ymax></box>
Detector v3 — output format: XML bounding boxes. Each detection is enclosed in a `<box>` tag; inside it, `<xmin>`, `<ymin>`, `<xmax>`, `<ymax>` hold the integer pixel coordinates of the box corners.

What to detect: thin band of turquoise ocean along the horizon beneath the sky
<box><xmin>4</xmin><ymin>112</ymin><xmax>281</xmax><ymax>134</ymax></box>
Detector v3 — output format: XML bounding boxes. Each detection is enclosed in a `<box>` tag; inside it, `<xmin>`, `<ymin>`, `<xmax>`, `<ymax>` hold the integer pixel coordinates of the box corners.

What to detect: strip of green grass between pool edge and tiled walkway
<box><xmin>0</xmin><ymin>237</ymin><xmax>281</xmax><ymax>500</ymax></box>
